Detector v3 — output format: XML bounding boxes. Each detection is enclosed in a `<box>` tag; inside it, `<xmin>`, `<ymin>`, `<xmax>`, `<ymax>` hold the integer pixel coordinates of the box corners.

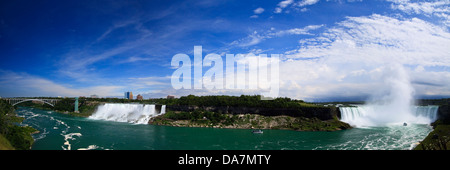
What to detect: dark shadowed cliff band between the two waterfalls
<box><xmin>166</xmin><ymin>105</ymin><xmax>340</xmax><ymax>120</ymax></box>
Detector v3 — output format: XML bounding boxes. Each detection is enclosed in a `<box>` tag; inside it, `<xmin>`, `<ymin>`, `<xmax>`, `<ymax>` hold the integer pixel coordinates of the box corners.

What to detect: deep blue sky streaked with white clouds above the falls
<box><xmin>0</xmin><ymin>0</ymin><xmax>450</xmax><ymax>101</ymax></box>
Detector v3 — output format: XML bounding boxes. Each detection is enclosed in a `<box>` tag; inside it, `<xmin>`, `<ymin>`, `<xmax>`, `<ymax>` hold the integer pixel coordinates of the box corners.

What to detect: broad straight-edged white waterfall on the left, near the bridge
<box><xmin>89</xmin><ymin>103</ymin><xmax>166</xmax><ymax>124</ymax></box>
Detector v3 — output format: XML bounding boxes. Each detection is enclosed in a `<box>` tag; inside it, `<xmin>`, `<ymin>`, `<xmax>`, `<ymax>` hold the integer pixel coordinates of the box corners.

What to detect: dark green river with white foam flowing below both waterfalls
<box><xmin>16</xmin><ymin>107</ymin><xmax>432</xmax><ymax>150</ymax></box>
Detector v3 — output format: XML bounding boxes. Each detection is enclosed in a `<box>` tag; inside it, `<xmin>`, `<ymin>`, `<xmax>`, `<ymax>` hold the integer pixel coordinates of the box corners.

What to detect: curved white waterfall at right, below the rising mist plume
<box><xmin>339</xmin><ymin>105</ymin><xmax>439</xmax><ymax>127</ymax></box>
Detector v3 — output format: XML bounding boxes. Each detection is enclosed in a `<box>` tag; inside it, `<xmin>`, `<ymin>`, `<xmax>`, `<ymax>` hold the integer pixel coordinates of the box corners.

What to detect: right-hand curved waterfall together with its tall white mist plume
<box><xmin>340</xmin><ymin>64</ymin><xmax>438</xmax><ymax>127</ymax></box>
